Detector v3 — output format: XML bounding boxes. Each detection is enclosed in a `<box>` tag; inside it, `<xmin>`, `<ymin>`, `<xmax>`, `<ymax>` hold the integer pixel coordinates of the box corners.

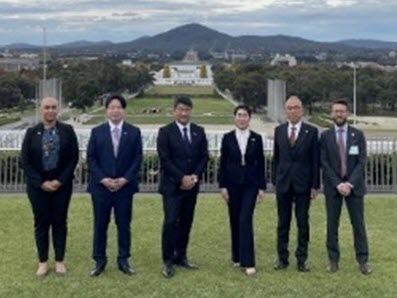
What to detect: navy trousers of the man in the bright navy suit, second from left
<box><xmin>92</xmin><ymin>192</ymin><xmax>133</xmax><ymax>265</ymax></box>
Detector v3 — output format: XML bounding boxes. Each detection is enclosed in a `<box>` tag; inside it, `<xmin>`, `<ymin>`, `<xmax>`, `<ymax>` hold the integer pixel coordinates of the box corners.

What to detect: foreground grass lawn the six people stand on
<box><xmin>0</xmin><ymin>194</ymin><xmax>397</xmax><ymax>298</ymax></box>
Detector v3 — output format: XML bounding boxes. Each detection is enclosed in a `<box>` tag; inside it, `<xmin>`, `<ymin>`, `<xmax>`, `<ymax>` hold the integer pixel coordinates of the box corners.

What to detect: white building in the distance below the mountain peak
<box><xmin>154</xmin><ymin>50</ymin><xmax>214</xmax><ymax>86</ymax></box>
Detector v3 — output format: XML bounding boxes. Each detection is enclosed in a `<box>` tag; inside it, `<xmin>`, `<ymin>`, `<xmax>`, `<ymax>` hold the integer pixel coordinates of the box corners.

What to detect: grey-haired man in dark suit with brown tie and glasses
<box><xmin>272</xmin><ymin>96</ymin><xmax>320</xmax><ymax>272</ymax></box>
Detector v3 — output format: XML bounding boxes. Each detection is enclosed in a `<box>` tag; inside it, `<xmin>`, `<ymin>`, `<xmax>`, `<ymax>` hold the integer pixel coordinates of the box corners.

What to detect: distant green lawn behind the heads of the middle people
<box><xmin>85</xmin><ymin>97</ymin><xmax>234</xmax><ymax>124</ymax></box>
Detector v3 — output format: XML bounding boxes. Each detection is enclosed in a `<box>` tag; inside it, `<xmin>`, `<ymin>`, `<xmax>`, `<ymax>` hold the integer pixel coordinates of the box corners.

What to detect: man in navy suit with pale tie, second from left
<box><xmin>87</xmin><ymin>95</ymin><xmax>142</xmax><ymax>276</ymax></box>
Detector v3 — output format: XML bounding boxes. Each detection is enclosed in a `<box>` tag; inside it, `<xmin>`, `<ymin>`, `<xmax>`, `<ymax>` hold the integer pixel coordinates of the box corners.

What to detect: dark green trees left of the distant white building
<box><xmin>0</xmin><ymin>60</ymin><xmax>153</xmax><ymax>110</ymax></box>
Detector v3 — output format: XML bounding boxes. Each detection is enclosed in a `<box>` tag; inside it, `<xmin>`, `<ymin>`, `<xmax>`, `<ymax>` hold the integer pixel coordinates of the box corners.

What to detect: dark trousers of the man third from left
<box><xmin>161</xmin><ymin>190</ymin><xmax>197</xmax><ymax>263</ymax></box>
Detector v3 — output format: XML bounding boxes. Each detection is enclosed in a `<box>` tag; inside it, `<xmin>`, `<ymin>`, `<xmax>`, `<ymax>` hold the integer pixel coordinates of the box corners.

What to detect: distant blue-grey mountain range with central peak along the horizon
<box><xmin>4</xmin><ymin>23</ymin><xmax>397</xmax><ymax>56</ymax></box>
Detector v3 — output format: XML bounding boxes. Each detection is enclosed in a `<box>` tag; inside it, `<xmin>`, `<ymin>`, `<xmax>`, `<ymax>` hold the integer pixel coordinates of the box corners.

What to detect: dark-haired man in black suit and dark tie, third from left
<box><xmin>157</xmin><ymin>96</ymin><xmax>208</xmax><ymax>277</ymax></box>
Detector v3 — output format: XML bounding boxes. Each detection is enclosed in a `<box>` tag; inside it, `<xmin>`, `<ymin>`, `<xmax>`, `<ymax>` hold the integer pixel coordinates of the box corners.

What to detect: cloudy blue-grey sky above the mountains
<box><xmin>0</xmin><ymin>0</ymin><xmax>397</xmax><ymax>45</ymax></box>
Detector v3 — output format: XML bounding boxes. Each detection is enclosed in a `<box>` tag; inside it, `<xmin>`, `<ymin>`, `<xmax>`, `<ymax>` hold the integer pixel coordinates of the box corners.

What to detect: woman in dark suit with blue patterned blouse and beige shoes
<box><xmin>21</xmin><ymin>97</ymin><xmax>79</xmax><ymax>277</ymax></box>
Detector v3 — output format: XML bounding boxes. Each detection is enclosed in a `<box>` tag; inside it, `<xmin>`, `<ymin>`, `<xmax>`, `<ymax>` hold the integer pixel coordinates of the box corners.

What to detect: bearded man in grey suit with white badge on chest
<box><xmin>320</xmin><ymin>100</ymin><xmax>371</xmax><ymax>275</ymax></box>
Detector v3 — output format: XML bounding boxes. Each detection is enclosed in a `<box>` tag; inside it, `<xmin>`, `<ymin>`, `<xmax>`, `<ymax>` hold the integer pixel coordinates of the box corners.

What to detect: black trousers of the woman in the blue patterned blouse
<box><xmin>27</xmin><ymin>183</ymin><xmax>73</xmax><ymax>262</ymax></box>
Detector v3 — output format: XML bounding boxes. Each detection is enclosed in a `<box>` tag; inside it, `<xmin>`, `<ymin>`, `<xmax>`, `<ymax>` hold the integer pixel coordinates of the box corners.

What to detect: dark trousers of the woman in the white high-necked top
<box><xmin>227</xmin><ymin>185</ymin><xmax>259</xmax><ymax>267</ymax></box>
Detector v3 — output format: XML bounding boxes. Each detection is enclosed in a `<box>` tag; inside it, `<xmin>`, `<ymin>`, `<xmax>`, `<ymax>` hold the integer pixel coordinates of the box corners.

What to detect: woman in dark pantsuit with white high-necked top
<box><xmin>219</xmin><ymin>105</ymin><xmax>266</xmax><ymax>276</ymax></box>
